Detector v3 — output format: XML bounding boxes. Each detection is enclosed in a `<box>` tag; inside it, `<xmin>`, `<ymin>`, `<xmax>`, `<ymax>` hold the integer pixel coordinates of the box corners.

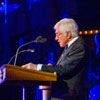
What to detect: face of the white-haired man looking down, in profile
<box><xmin>55</xmin><ymin>28</ymin><xmax>69</xmax><ymax>47</ymax></box>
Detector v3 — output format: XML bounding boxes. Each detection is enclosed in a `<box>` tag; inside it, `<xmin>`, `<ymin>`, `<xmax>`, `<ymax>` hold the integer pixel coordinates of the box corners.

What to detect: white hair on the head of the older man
<box><xmin>54</xmin><ymin>18</ymin><xmax>78</xmax><ymax>37</ymax></box>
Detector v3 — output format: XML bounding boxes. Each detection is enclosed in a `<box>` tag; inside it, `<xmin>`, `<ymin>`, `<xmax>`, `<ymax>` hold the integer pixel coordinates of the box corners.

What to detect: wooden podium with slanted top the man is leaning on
<box><xmin>0</xmin><ymin>64</ymin><xmax>57</xmax><ymax>100</ymax></box>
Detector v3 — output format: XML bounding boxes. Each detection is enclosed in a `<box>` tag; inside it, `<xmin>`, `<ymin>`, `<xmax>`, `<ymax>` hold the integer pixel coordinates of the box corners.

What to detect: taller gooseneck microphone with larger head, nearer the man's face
<box><xmin>14</xmin><ymin>36</ymin><xmax>47</xmax><ymax>66</ymax></box>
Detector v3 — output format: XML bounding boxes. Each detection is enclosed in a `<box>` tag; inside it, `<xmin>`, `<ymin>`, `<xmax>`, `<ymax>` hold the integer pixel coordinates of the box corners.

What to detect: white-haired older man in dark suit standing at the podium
<box><xmin>22</xmin><ymin>18</ymin><xmax>89</xmax><ymax>100</ymax></box>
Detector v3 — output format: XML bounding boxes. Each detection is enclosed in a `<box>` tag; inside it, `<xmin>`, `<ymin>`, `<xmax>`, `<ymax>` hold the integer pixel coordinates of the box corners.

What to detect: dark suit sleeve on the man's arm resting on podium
<box><xmin>42</xmin><ymin>45</ymin><xmax>85</xmax><ymax>76</ymax></box>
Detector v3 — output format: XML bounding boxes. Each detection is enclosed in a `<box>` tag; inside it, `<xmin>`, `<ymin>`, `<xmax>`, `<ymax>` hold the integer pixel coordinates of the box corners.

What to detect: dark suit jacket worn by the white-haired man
<box><xmin>42</xmin><ymin>37</ymin><xmax>89</xmax><ymax>100</ymax></box>
